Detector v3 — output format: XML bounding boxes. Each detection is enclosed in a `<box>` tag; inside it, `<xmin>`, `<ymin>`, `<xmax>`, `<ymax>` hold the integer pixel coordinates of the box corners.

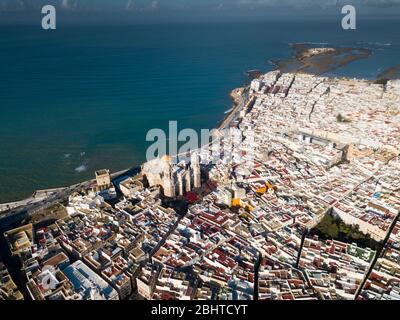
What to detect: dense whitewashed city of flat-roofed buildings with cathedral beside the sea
<box><xmin>1</xmin><ymin>71</ymin><xmax>400</xmax><ymax>300</ymax></box>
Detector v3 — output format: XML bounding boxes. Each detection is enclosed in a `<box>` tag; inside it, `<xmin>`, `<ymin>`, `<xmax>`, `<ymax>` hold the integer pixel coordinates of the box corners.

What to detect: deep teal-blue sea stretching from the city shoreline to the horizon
<box><xmin>0</xmin><ymin>19</ymin><xmax>400</xmax><ymax>202</ymax></box>
